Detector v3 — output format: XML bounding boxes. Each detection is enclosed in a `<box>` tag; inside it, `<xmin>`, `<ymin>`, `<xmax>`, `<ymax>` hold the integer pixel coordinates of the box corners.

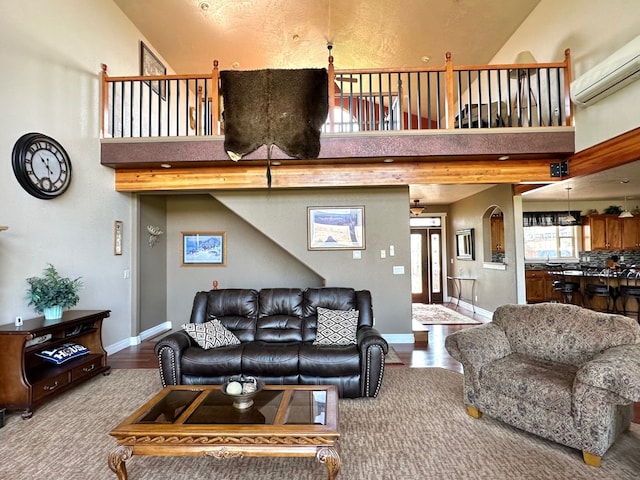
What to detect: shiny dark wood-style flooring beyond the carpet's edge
<box><xmin>108</xmin><ymin>307</ymin><xmax>640</xmax><ymax>423</ymax></box>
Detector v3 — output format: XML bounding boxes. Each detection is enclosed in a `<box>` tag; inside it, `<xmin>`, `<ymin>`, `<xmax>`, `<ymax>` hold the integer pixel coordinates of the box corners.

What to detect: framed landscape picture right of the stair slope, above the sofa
<box><xmin>307</xmin><ymin>206</ymin><xmax>365</xmax><ymax>250</ymax></box>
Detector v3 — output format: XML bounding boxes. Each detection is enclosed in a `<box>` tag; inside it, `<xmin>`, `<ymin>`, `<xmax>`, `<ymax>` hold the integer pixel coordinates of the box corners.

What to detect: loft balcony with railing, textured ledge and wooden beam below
<box><xmin>101</xmin><ymin>50</ymin><xmax>574</xmax><ymax>192</ymax></box>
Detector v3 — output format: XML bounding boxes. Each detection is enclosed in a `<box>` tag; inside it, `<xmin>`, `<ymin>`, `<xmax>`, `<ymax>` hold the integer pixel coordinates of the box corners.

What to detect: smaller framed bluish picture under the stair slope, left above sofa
<box><xmin>180</xmin><ymin>232</ymin><xmax>227</xmax><ymax>267</ymax></box>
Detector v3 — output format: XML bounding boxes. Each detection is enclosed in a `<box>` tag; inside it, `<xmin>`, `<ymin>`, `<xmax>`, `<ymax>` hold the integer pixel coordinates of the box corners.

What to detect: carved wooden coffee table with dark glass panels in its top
<box><xmin>109</xmin><ymin>385</ymin><xmax>340</xmax><ymax>480</ymax></box>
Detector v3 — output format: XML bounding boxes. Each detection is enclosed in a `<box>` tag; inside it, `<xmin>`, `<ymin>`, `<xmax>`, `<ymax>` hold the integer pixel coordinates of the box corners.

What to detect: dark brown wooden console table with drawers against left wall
<box><xmin>0</xmin><ymin>310</ymin><xmax>111</xmax><ymax>419</ymax></box>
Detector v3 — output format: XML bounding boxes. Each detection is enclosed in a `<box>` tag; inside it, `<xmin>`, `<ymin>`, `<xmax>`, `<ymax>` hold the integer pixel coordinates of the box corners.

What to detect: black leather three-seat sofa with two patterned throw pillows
<box><xmin>155</xmin><ymin>288</ymin><xmax>388</xmax><ymax>398</ymax></box>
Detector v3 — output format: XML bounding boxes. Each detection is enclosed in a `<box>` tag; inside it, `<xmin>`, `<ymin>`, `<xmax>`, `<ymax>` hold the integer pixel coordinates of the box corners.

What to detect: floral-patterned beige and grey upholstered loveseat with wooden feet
<box><xmin>445</xmin><ymin>303</ymin><xmax>640</xmax><ymax>466</ymax></box>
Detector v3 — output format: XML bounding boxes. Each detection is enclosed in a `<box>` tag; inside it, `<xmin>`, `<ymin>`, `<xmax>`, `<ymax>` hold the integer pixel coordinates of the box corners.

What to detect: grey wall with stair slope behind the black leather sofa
<box><xmin>159</xmin><ymin>187</ymin><xmax>411</xmax><ymax>334</ymax></box>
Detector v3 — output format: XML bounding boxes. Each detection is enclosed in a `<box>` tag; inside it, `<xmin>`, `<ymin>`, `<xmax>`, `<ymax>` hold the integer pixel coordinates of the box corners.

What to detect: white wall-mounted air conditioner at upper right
<box><xmin>571</xmin><ymin>35</ymin><xmax>640</xmax><ymax>105</ymax></box>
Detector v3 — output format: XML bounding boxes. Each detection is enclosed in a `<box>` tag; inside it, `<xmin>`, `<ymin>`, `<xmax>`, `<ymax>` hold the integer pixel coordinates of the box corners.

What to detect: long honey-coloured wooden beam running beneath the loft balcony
<box><xmin>115</xmin><ymin>160</ymin><xmax>558</xmax><ymax>192</ymax></box>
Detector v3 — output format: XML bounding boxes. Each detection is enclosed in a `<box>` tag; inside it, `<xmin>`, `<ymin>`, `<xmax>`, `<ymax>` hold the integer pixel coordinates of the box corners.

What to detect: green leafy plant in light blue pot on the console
<box><xmin>27</xmin><ymin>264</ymin><xmax>82</xmax><ymax>320</ymax></box>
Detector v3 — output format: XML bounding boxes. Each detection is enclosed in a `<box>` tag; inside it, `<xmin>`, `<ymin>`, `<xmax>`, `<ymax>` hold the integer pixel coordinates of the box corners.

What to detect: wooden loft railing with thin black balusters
<box><xmin>101</xmin><ymin>49</ymin><xmax>573</xmax><ymax>138</ymax></box>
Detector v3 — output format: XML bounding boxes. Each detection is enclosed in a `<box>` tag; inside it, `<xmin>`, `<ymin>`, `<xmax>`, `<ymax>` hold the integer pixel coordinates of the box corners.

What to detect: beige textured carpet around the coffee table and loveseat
<box><xmin>0</xmin><ymin>367</ymin><xmax>640</xmax><ymax>480</ymax></box>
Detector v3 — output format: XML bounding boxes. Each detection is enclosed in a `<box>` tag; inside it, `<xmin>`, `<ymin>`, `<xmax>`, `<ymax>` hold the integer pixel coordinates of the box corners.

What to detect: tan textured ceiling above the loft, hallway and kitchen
<box><xmin>114</xmin><ymin>0</ymin><xmax>640</xmax><ymax>205</ymax></box>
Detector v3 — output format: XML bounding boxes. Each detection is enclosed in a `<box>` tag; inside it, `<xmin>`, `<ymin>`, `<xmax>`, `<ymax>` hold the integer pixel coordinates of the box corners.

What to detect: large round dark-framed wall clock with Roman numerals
<box><xmin>11</xmin><ymin>133</ymin><xmax>71</xmax><ymax>200</ymax></box>
